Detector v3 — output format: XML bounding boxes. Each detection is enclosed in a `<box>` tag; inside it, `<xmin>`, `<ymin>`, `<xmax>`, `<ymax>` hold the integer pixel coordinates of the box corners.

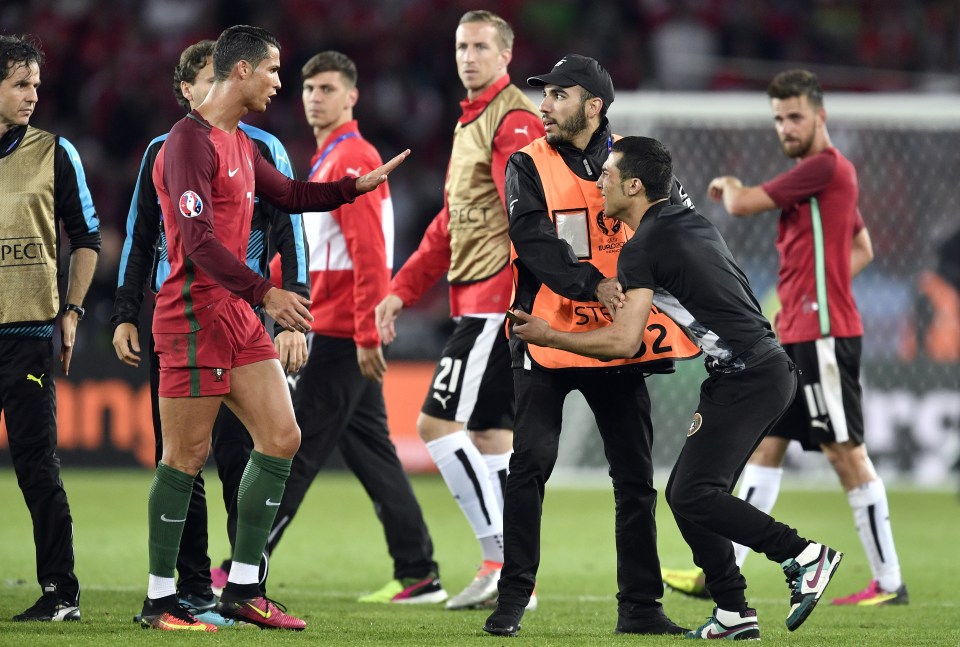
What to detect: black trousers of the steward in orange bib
<box><xmin>499</xmin><ymin>368</ymin><xmax>663</xmax><ymax>618</ymax></box>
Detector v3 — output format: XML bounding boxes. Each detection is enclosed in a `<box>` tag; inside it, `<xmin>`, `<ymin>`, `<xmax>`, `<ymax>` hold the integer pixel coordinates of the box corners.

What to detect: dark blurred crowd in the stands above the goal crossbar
<box><xmin>0</xmin><ymin>0</ymin><xmax>960</xmax><ymax>354</ymax></box>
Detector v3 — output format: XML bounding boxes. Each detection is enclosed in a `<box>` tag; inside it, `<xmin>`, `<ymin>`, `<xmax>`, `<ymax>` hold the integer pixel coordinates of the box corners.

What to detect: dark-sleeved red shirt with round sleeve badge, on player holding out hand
<box><xmin>153</xmin><ymin>111</ymin><xmax>357</xmax><ymax>332</ymax></box>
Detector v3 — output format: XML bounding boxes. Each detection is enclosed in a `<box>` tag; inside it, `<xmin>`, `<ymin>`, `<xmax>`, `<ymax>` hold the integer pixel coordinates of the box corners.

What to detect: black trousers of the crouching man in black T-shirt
<box><xmin>668</xmin><ymin>351</ymin><xmax>808</xmax><ymax>611</ymax></box>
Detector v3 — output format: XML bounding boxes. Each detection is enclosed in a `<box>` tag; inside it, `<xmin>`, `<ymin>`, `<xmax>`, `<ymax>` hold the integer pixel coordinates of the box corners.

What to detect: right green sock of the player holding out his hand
<box><xmin>233</xmin><ymin>451</ymin><xmax>293</xmax><ymax>564</ymax></box>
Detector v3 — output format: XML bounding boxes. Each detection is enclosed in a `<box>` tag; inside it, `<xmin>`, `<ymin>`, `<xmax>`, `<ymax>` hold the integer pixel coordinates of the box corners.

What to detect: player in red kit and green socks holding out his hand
<box><xmin>141</xmin><ymin>25</ymin><xmax>409</xmax><ymax>631</ymax></box>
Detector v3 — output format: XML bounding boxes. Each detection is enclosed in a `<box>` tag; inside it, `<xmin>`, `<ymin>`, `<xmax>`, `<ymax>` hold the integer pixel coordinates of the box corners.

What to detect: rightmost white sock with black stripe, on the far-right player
<box><xmin>847</xmin><ymin>479</ymin><xmax>903</xmax><ymax>593</ymax></box>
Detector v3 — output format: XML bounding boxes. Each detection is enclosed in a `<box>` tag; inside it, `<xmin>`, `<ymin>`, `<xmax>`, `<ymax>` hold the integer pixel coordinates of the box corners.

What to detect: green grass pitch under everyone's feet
<box><xmin>0</xmin><ymin>469</ymin><xmax>960</xmax><ymax>647</ymax></box>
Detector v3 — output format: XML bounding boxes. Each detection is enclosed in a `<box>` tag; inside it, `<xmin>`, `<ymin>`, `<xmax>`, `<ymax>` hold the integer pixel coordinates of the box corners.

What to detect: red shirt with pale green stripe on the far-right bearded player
<box><xmin>762</xmin><ymin>148</ymin><xmax>864</xmax><ymax>344</ymax></box>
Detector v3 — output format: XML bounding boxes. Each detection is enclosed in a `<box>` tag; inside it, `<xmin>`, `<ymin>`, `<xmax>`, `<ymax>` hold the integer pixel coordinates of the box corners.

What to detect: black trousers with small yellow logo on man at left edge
<box><xmin>0</xmin><ymin>337</ymin><xmax>80</xmax><ymax>604</ymax></box>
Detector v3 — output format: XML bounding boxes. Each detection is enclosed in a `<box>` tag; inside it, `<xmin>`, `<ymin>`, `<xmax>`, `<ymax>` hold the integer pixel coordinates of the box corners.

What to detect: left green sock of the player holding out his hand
<box><xmin>147</xmin><ymin>463</ymin><xmax>194</xmax><ymax>577</ymax></box>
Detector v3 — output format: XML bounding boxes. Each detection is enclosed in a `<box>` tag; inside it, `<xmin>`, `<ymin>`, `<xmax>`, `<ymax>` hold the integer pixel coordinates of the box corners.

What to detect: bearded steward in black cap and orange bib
<box><xmin>484</xmin><ymin>54</ymin><xmax>700</xmax><ymax>635</ymax></box>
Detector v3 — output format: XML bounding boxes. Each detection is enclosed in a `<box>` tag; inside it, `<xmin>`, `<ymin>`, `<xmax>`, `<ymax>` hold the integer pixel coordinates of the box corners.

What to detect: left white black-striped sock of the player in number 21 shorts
<box><xmin>427</xmin><ymin>431</ymin><xmax>503</xmax><ymax>548</ymax></box>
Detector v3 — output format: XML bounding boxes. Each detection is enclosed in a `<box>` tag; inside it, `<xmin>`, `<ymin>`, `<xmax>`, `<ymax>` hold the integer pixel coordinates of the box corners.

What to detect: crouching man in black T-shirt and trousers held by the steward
<box><xmin>511</xmin><ymin>137</ymin><xmax>842</xmax><ymax>640</ymax></box>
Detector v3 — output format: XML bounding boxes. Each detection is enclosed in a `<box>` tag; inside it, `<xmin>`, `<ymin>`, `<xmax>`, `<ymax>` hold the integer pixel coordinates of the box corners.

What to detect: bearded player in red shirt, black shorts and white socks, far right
<box><xmin>665</xmin><ymin>70</ymin><xmax>908</xmax><ymax>606</ymax></box>
